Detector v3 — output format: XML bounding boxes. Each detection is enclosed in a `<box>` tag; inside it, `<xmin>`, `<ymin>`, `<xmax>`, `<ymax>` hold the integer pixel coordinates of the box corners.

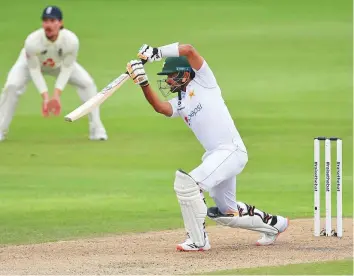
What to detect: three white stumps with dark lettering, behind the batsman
<box><xmin>314</xmin><ymin>137</ymin><xmax>343</xmax><ymax>237</ymax></box>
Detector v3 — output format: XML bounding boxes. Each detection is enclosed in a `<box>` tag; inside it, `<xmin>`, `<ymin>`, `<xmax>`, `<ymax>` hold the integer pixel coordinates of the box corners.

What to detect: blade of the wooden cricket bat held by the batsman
<box><xmin>64</xmin><ymin>73</ymin><xmax>130</xmax><ymax>122</ymax></box>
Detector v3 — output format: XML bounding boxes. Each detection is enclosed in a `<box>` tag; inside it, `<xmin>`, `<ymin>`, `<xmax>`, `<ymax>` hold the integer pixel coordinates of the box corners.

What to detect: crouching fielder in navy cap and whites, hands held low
<box><xmin>0</xmin><ymin>6</ymin><xmax>108</xmax><ymax>141</ymax></box>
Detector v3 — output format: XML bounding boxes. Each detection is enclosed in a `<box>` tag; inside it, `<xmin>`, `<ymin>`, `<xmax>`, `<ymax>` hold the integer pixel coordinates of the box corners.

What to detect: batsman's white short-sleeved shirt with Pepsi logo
<box><xmin>169</xmin><ymin>61</ymin><xmax>246</xmax><ymax>151</ymax></box>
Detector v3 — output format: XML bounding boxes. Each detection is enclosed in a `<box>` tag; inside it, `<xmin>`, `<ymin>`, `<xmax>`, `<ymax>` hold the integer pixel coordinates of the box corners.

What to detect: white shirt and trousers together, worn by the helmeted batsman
<box><xmin>169</xmin><ymin>61</ymin><xmax>248</xmax><ymax>212</ymax></box>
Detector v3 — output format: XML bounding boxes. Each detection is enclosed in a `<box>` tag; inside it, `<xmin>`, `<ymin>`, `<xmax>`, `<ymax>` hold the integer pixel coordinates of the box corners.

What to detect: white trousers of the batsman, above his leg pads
<box><xmin>190</xmin><ymin>144</ymin><xmax>248</xmax><ymax>213</ymax></box>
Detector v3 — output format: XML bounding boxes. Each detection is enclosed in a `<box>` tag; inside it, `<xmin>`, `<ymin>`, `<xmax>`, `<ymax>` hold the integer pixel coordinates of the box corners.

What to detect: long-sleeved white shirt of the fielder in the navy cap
<box><xmin>24</xmin><ymin>28</ymin><xmax>79</xmax><ymax>93</ymax></box>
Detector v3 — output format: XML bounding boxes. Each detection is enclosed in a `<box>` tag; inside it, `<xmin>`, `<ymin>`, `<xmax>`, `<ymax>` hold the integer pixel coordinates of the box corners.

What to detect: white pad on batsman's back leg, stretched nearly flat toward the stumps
<box><xmin>208</xmin><ymin>207</ymin><xmax>279</xmax><ymax>235</ymax></box>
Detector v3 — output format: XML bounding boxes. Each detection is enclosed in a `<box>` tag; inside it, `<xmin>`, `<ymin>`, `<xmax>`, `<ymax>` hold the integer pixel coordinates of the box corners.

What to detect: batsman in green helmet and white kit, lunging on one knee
<box><xmin>127</xmin><ymin>43</ymin><xmax>288</xmax><ymax>251</ymax></box>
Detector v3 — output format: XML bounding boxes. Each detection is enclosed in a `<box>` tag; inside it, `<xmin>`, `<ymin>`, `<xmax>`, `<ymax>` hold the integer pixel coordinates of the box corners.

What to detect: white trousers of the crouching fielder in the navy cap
<box><xmin>0</xmin><ymin>49</ymin><xmax>103</xmax><ymax>134</ymax></box>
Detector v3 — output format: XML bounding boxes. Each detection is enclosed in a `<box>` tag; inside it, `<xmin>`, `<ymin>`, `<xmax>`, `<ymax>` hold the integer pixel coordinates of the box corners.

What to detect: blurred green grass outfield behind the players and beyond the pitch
<box><xmin>0</xmin><ymin>0</ymin><xmax>353</xmax><ymax>244</ymax></box>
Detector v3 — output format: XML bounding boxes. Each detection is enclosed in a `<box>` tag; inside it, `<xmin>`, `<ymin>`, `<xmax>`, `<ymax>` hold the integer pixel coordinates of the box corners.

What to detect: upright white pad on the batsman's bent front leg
<box><xmin>174</xmin><ymin>170</ymin><xmax>207</xmax><ymax>247</ymax></box>
